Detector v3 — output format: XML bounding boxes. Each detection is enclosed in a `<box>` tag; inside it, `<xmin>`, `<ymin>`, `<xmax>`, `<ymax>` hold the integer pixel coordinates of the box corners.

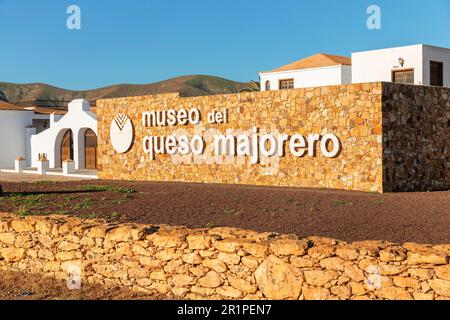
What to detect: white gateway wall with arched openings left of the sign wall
<box><xmin>31</xmin><ymin>100</ymin><xmax>97</xmax><ymax>169</ymax></box>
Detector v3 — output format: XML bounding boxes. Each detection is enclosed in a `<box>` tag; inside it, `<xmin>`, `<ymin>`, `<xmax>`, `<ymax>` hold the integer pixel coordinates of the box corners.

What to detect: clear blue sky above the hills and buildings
<box><xmin>0</xmin><ymin>0</ymin><xmax>450</xmax><ymax>89</ymax></box>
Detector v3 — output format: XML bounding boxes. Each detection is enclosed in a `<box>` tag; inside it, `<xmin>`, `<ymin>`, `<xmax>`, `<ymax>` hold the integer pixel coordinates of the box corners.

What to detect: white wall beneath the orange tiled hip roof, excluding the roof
<box><xmin>260</xmin><ymin>66</ymin><xmax>352</xmax><ymax>91</ymax></box>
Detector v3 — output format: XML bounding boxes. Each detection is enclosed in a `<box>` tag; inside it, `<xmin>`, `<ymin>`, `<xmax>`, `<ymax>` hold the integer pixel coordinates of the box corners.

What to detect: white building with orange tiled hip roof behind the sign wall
<box><xmin>259</xmin><ymin>53</ymin><xmax>352</xmax><ymax>91</ymax></box>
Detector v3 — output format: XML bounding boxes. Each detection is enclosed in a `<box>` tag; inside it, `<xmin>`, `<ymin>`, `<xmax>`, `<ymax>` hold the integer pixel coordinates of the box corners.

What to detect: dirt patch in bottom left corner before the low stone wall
<box><xmin>0</xmin><ymin>271</ymin><xmax>166</xmax><ymax>300</ymax></box>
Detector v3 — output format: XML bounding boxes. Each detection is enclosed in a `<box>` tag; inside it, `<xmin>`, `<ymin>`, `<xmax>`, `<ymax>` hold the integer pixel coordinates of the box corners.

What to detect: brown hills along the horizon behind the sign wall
<box><xmin>0</xmin><ymin>75</ymin><xmax>258</xmax><ymax>105</ymax></box>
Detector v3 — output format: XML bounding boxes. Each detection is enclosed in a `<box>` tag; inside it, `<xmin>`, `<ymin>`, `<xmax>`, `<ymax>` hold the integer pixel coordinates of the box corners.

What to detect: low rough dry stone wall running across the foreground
<box><xmin>0</xmin><ymin>214</ymin><xmax>450</xmax><ymax>300</ymax></box>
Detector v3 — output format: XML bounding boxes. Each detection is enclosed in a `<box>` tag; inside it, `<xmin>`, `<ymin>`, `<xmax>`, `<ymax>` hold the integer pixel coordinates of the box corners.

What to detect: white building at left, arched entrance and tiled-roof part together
<box><xmin>0</xmin><ymin>100</ymin><xmax>97</xmax><ymax>175</ymax></box>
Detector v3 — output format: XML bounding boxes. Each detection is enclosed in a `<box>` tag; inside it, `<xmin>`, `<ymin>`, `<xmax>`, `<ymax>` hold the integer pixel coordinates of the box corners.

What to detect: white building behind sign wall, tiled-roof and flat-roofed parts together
<box><xmin>260</xmin><ymin>44</ymin><xmax>450</xmax><ymax>91</ymax></box>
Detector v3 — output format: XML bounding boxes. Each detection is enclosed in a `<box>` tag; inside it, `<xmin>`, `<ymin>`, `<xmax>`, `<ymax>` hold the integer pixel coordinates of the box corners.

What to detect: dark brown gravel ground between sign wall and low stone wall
<box><xmin>0</xmin><ymin>181</ymin><xmax>450</xmax><ymax>244</ymax></box>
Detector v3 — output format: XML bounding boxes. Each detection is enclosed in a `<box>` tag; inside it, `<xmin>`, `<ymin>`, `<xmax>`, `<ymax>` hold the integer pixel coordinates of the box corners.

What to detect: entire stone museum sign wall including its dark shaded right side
<box><xmin>97</xmin><ymin>83</ymin><xmax>450</xmax><ymax>192</ymax></box>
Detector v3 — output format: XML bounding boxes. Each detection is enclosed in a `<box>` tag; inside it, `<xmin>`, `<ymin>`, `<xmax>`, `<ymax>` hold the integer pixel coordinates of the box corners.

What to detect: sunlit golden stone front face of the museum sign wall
<box><xmin>97</xmin><ymin>83</ymin><xmax>382</xmax><ymax>192</ymax></box>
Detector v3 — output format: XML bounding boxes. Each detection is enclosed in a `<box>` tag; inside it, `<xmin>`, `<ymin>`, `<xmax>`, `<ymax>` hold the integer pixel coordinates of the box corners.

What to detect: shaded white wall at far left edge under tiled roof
<box><xmin>0</xmin><ymin>110</ymin><xmax>34</xmax><ymax>168</ymax></box>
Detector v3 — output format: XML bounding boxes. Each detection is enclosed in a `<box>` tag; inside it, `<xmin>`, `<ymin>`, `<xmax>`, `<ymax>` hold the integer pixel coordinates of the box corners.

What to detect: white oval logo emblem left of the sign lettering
<box><xmin>109</xmin><ymin>113</ymin><xmax>134</xmax><ymax>153</ymax></box>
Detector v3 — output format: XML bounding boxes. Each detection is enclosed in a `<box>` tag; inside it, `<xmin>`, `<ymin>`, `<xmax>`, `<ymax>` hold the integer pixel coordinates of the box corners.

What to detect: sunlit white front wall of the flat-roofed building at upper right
<box><xmin>352</xmin><ymin>45</ymin><xmax>424</xmax><ymax>85</ymax></box>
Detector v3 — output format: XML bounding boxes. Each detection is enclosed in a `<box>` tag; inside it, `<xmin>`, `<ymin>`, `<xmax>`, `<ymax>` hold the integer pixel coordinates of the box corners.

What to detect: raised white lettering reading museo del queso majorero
<box><xmin>142</xmin><ymin>108</ymin><xmax>341</xmax><ymax>164</ymax></box>
